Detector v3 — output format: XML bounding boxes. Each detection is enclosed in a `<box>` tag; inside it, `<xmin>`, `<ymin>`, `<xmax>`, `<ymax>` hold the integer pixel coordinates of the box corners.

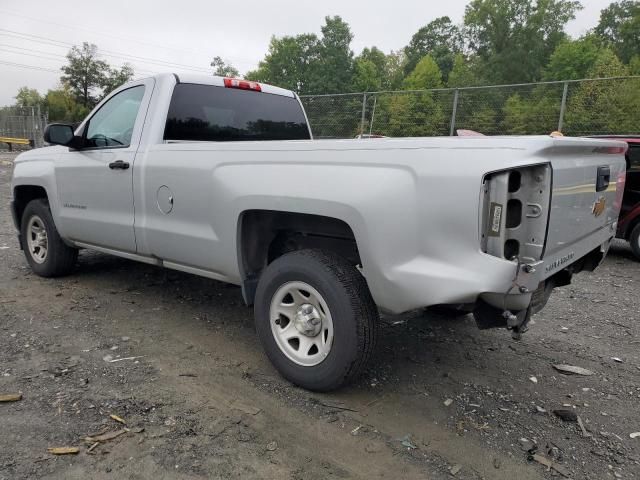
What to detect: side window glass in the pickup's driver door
<box><xmin>86</xmin><ymin>85</ymin><xmax>144</xmax><ymax>148</ymax></box>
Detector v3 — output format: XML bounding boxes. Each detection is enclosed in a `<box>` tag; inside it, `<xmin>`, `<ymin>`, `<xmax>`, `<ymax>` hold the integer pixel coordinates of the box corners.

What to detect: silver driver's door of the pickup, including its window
<box><xmin>55</xmin><ymin>79</ymin><xmax>153</xmax><ymax>252</ymax></box>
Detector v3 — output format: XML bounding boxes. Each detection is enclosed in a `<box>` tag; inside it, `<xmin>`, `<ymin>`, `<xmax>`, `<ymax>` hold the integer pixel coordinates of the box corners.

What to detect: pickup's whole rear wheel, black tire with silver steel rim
<box><xmin>255</xmin><ymin>250</ymin><xmax>379</xmax><ymax>391</ymax></box>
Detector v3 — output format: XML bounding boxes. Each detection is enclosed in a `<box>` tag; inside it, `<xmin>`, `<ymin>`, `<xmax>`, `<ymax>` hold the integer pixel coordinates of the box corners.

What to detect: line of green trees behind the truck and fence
<box><xmin>10</xmin><ymin>0</ymin><xmax>640</xmax><ymax>135</ymax></box>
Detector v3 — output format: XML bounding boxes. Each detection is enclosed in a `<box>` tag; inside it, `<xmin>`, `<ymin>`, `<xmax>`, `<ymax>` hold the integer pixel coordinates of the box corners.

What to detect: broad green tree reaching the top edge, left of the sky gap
<box><xmin>464</xmin><ymin>0</ymin><xmax>582</xmax><ymax>83</ymax></box>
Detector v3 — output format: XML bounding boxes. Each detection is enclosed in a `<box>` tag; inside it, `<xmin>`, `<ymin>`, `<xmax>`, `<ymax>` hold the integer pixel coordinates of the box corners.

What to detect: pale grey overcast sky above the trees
<box><xmin>0</xmin><ymin>0</ymin><xmax>611</xmax><ymax>105</ymax></box>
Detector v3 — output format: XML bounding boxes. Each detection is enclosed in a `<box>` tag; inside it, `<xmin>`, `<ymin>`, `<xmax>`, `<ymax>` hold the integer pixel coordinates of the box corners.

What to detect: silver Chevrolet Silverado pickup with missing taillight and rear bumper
<box><xmin>12</xmin><ymin>74</ymin><xmax>626</xmax><ymax>390</ymax></box>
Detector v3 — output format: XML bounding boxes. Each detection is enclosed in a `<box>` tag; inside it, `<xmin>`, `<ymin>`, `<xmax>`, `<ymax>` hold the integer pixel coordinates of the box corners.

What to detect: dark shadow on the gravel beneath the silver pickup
<box><xmin>68</xmin><ymin>251</ymin><xmax>490</xmax><ymax>388</ymax></box>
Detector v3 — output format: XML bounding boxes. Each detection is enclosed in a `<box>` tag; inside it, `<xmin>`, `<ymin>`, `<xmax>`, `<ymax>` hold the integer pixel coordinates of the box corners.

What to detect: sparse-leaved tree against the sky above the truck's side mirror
<box><xmin>60</xmin><ymin>42</ymin><xmax>109</xmax><ymax>107</ymax></box>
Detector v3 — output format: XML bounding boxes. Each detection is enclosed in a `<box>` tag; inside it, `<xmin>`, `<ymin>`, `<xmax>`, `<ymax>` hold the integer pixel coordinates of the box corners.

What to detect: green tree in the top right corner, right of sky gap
<box><xmin>595</xmin><ymin>0</ymin><xmax>640</xmax><ymax>63</ymax></box>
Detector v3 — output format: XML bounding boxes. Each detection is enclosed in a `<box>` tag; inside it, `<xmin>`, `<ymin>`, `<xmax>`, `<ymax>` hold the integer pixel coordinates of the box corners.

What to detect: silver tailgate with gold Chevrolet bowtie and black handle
<box><xmin>540</xmin><ymin>138</ymin><xmax>626</xmax><ymax>259</ymax></box>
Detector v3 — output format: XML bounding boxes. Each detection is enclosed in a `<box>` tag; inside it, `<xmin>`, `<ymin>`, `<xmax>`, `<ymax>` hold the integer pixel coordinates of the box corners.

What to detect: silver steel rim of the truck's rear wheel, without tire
<box><xmin>269</xmin><ymin>282</ymin><xmax>333</xmax><ymax>367</ymax></box>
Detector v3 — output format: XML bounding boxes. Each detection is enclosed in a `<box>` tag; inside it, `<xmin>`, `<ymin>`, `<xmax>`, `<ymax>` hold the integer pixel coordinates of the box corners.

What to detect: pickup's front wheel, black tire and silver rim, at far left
<box><xmin>20</xmin><ymin>198</ymin><xmax>78</xmax><ymax>277</ymax></box>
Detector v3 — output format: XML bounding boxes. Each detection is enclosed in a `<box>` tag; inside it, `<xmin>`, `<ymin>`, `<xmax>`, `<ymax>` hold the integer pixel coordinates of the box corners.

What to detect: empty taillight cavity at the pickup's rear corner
<box><xmin>480</xmin><ymin>164</ymin><xmax>552</xmax><ymax>263</ymax></box>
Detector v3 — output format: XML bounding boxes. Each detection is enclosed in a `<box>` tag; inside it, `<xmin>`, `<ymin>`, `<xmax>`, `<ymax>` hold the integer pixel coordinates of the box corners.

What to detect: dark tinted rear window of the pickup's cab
<box><xmin>164</xmin><ymin>83</ymin><xmax>310</xmax><ymax>142</ymax></box>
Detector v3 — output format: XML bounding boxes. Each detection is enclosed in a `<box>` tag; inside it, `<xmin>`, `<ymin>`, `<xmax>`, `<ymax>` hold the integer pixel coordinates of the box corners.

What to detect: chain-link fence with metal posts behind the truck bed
<box><xmin>301</xmin><ymin>76</ymin><xmax>640</xmax><ymax>138</ymax></box>
